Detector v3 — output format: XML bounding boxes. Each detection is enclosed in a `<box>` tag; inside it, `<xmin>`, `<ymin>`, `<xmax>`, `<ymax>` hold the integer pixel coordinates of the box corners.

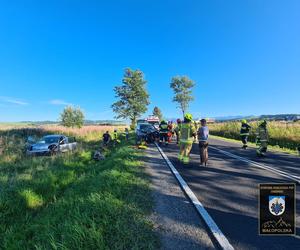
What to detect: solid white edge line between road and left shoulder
<box><xmin>155</xmin><ymin>143</ymin><xmax>234</xmax><ymax>250</ymax></box>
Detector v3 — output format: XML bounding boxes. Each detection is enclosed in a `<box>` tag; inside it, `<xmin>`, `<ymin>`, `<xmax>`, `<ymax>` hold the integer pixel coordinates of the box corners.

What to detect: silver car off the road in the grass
<box><xmin>26</xmin><ymin>135</ymin><xmax>77</xmax><ymax>155</ymax></box>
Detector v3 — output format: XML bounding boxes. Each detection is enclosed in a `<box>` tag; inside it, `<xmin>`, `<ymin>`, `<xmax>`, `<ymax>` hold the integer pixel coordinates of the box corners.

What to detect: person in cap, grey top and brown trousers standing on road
<box><xmin>197</xmin><ymin>119</ymin><xmax>209</xmax><ymax>166</ymax></box>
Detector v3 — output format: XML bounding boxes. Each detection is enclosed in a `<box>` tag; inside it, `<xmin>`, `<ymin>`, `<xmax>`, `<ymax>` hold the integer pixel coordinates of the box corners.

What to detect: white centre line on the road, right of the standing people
<box><xmin>209</xmin><ymin>146</ymin><xmax>300</xmax><ymax>184</ymax></box>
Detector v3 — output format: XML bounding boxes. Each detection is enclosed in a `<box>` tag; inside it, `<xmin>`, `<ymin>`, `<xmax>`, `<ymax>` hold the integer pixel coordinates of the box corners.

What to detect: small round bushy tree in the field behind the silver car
<box><xmin>60</xmin><ymin>106</ymin><xmax>84</xmax><ymax>128</ymax></box>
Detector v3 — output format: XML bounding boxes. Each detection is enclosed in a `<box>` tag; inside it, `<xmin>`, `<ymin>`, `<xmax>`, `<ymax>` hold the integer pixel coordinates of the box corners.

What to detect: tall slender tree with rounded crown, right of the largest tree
<box><xmin>170</xmin><ymin>76</ymin><xmax>195</xmax><ymax>115</ymax></box>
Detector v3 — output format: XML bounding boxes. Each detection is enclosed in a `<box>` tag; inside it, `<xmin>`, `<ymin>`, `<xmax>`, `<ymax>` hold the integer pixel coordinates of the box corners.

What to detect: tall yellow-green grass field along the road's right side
<box><xmin>209</xmin><ymin>121</ymin><xmax>300</xmax><ymax>150</ymax></box>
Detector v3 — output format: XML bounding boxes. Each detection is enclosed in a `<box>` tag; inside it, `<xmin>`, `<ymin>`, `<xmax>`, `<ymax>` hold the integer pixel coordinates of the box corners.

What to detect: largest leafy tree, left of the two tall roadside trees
<box><xmin>112</xmin><ymin>68</ymin><xmax>149</xmax><ymax>128</ymax></box>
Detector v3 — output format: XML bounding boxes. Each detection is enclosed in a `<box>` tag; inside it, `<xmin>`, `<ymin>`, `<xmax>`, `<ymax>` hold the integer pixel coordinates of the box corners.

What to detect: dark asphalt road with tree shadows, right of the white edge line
<box><xmin>161</xmin><ymin>139</ymin><xmax>300</xmax><ymax>250</ymax></box>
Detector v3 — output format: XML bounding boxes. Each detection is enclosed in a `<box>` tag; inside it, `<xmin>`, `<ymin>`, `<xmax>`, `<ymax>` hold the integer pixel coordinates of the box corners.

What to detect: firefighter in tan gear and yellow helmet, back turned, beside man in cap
<box><xmin>178</xmin><ymin>114</ymin><xmax>196</xmax><ymax>164</ymax></box>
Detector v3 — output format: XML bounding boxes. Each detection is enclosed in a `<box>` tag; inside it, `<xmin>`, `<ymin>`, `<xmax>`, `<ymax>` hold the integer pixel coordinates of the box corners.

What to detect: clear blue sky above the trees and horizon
<box><xmin>0</xmin><ymin>0</ymin><xmax>300</xmax><ymax>121</ymax></box>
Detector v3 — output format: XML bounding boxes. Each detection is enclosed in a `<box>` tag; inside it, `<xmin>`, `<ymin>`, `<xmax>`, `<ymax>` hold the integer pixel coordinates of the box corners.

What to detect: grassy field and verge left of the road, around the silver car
<box><xmin>0</xmin><ymin>126</ymin><xmax>158</xmax><ymax>249</ymax></box>
